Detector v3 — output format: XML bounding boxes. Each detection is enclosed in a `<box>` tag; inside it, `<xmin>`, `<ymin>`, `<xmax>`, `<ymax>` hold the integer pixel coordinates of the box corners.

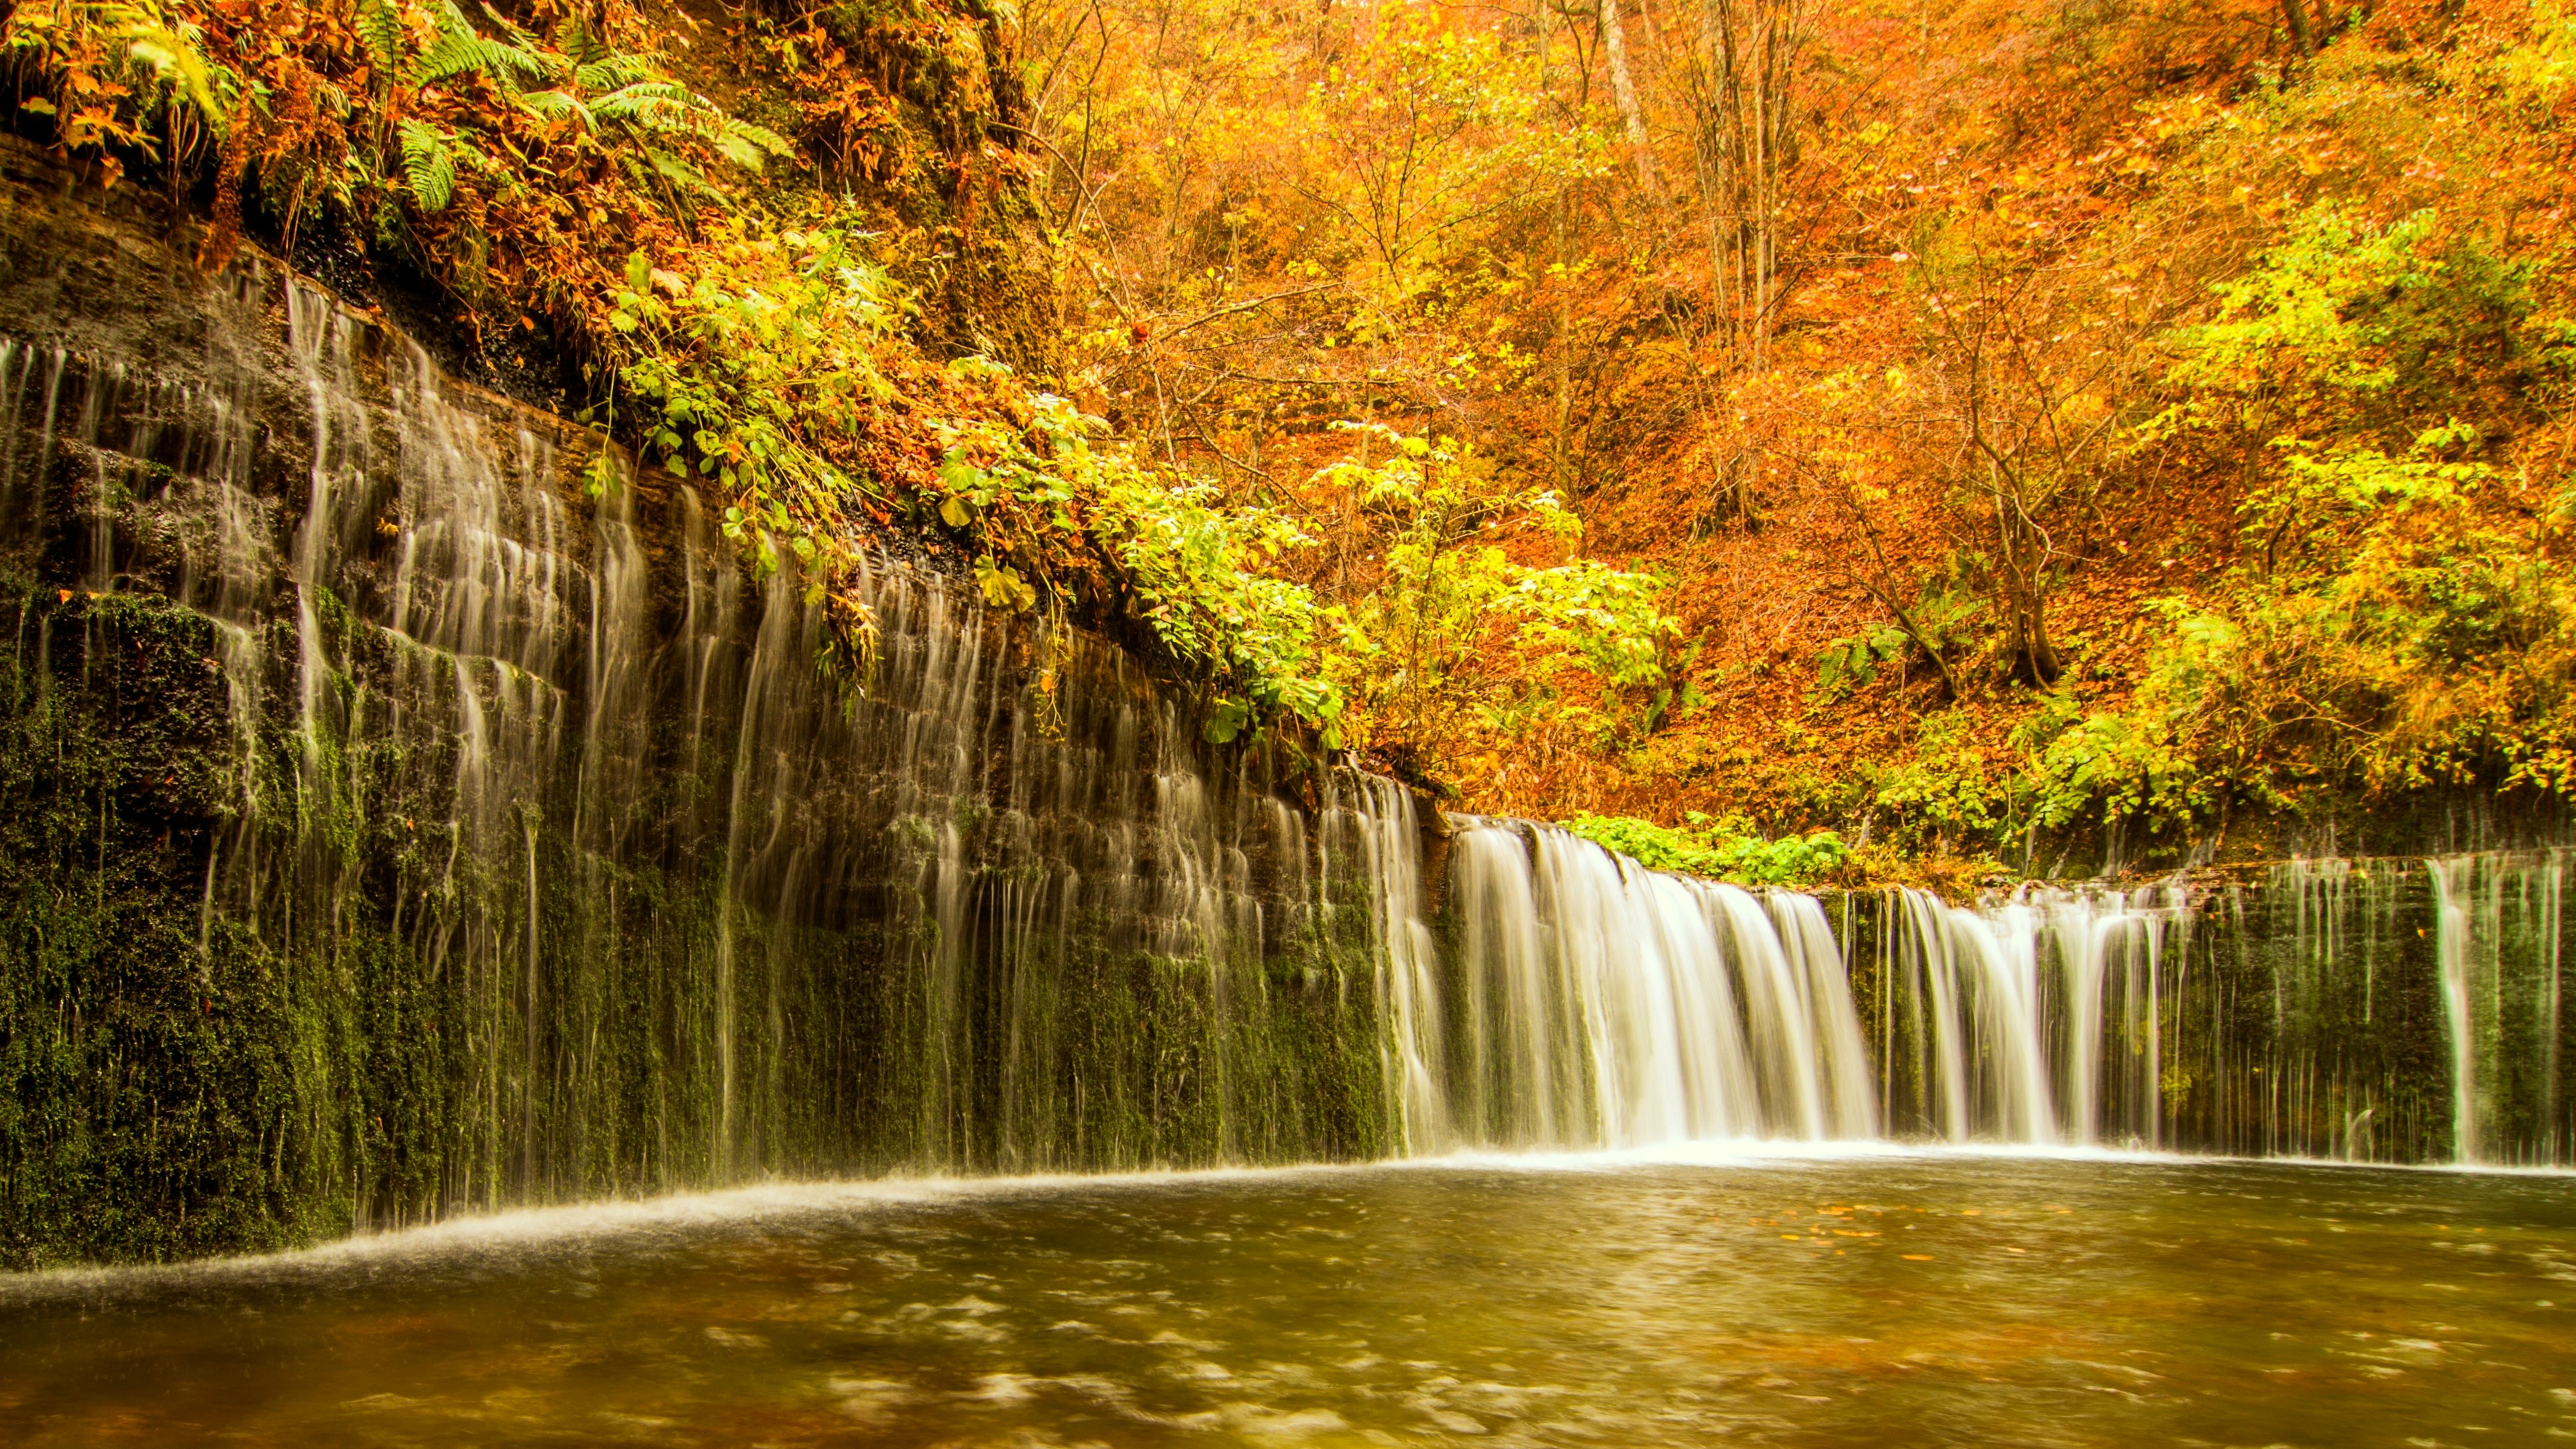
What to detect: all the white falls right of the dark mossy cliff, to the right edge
<box><xmin>1391</xmin><ymin>820</ymin><xmax>2576</xmax><ymax>1165</ymax></box>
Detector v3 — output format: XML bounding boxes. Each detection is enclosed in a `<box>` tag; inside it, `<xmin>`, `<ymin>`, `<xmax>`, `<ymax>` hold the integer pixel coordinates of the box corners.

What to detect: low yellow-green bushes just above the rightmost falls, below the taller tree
<box><xmin>2017</xmin><ymin>479</ymin><xmax>2576</xmax><ymax>835</ymax></box>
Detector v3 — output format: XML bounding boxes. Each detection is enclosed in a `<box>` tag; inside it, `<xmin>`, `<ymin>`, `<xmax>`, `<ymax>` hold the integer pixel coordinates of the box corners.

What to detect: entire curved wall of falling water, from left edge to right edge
<box><xmin>0</xmin><ymin>216</ymin><xmax>2576</xmax><ymax>1260</ymax></box>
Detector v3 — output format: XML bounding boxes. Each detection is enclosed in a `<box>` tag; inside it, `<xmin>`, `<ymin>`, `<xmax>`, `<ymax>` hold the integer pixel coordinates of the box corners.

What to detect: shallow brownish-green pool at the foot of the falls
<box><xmin>0</xmin><ymin>1155</ymin><xmax>2576</xmax><ymax>1446</ymax></box>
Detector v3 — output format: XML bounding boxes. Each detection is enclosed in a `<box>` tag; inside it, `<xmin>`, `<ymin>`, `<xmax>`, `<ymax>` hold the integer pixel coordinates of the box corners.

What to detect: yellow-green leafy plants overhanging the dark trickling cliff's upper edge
<box><xmin>613</xmin><ymin>219</ymin><xmax>1342</xmax><ymax>743</ymax></box>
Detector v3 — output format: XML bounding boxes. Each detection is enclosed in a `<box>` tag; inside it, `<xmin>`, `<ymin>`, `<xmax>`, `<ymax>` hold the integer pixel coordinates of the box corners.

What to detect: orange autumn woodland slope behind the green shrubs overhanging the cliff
<box><xmin>1033</xmin><ymin>0</ymin><xmax>2576</xmax><ymax>869</ymax></box>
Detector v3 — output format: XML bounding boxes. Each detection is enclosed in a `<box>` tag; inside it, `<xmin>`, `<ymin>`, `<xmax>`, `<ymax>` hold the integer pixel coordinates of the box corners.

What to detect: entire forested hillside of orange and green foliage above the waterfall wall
<box><xmin>5</xmin><ymin>0</ymin><xmax>2576</xmax><ymax>879</ymax></box>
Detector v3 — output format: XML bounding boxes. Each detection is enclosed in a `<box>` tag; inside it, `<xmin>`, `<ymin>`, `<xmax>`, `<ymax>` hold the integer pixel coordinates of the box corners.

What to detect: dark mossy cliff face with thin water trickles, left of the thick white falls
<box><xmin>0</xmin><ymin>138</ymin><xmax>1409</xmax><ymax>1266</ymax></box>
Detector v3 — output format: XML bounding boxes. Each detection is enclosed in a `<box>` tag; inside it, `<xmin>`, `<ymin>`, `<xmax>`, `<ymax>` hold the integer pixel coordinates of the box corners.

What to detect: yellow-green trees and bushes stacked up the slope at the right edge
<box><xmin>2022</xmin><ymin>204</ymin><xmax>2576</xmax><ymax>833</ymax></box>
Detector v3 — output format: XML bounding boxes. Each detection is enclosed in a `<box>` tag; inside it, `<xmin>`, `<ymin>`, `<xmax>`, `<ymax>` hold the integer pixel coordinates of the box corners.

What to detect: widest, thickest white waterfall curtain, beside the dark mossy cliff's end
<box><xmin>1432</xmin><ymin>820</ymin><xmax>1878</xmax><ymax>1147</ymax></box>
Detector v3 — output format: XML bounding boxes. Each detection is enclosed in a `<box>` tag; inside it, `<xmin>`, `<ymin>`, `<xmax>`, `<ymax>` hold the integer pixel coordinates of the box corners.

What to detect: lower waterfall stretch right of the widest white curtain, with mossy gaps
<box><xmin>1855</xmin><ymin>851</ymin><xmax>2576</xmax><ymax>1165</ymax></box>
